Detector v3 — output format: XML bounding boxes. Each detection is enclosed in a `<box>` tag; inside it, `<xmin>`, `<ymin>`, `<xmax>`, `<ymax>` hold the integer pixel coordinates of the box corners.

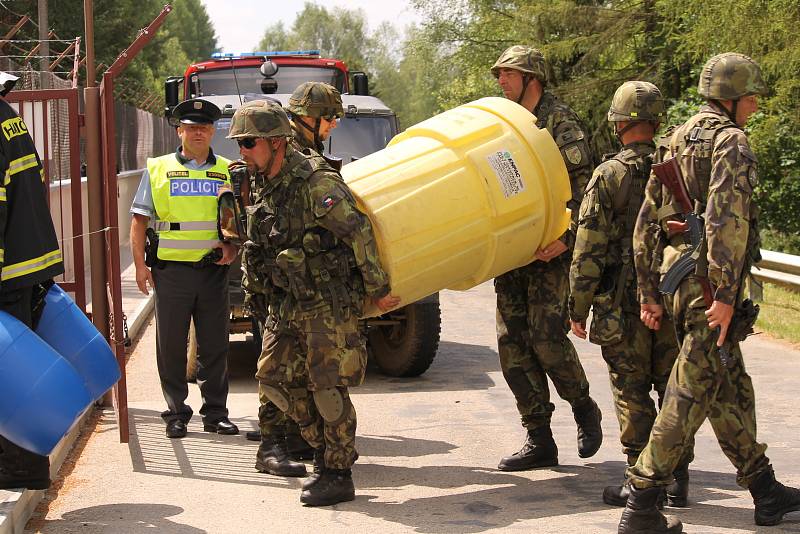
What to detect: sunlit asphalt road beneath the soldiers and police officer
<box><xmin>29</xmin><ymin>284</ymin><xmax>800</xmax><ymax>534</ymax></box>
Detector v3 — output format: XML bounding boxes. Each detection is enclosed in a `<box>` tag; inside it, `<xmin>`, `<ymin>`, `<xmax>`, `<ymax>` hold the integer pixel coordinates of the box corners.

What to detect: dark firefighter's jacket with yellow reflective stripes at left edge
<box><xmin>0</xmin><ymin>100</ymin><xmax>64</xmax><ymax>292</ymax></box>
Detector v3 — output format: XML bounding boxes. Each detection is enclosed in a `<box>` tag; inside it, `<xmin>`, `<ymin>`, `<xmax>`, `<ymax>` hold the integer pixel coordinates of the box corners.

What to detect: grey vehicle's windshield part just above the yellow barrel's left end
<box><xmin>325</xmin><ymin>115</ymin><xmax>397</xmax><ymax>164</ymax></box>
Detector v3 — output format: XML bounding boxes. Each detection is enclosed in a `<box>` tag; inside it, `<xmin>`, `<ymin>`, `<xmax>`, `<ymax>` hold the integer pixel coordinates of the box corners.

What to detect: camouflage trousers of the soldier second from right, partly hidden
<box><xmin>601</xmin><ymin>311</ymin><xmax>694</xmax><ymax>466</ymax></box>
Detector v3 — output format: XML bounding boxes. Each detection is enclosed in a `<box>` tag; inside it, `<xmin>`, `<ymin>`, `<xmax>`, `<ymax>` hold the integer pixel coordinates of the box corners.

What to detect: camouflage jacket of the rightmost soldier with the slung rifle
<box><xmin>634</xmin><ymin>105</ymin><xmax>760</xmax><ymax>304</ymax></box>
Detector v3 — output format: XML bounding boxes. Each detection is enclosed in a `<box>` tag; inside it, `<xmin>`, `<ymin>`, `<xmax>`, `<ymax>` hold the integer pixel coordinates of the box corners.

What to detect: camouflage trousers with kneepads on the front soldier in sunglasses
<box><xmin>256</xmin><ymin>316</ymin><xmax>367</xmax><ymax>469</ymax></box>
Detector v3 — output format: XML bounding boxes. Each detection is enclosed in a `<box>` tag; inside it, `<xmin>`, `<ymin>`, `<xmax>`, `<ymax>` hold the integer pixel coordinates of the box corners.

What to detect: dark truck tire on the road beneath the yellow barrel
<box><xmin>368</xmin><ymin>299</ymin><xmax>441</xmax><ymax>377</ymax></box>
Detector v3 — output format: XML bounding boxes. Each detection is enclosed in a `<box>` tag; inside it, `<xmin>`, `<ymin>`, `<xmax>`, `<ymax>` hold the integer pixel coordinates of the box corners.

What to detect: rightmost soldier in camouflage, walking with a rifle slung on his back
<box><xmin>619</xmin><ymin>53</ymin><xmax>800</xmax><ymax>534</ymax></box>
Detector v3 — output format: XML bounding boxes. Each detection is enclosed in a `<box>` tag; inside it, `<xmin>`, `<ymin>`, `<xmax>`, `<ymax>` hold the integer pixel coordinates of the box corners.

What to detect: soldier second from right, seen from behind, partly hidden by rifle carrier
<box><xmin>569</xmin><ymin>81</ymin><xmax>693</xmax><ymax>506</ymax></box>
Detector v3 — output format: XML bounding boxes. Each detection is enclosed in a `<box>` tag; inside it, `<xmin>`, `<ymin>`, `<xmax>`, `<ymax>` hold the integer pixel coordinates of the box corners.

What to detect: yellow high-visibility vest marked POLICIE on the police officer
<box><xmin>147</xmin><ymin>154</ymin><xmax>230</xmax><ymax>262</ymax></box>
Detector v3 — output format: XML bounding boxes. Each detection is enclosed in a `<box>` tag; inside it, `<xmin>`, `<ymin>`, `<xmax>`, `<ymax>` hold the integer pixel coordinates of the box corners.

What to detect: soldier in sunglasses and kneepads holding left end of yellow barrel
<box><xmin>229</xmin><ymin>100</ymin><xmax>399</xmax><ymax>506</ymax></box>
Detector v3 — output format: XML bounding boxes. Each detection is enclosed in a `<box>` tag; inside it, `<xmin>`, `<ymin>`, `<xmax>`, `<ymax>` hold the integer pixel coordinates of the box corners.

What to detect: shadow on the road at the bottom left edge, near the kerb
<box><xmin>30</xmin><ymin>503</ymin><xmax>206</xmax><ymax>534</ymax></box>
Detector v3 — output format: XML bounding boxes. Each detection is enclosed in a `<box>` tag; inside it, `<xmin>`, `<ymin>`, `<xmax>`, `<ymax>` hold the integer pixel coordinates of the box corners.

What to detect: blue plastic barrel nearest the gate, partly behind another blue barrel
<box><xmin>36</xmin><ymin>284</ymin><xmax>120</xmax><ymax>400</ymax></box>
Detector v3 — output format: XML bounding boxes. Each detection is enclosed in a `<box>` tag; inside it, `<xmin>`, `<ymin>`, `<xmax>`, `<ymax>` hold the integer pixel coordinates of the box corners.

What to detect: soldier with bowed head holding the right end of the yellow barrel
<box><xmin>492</xmin><ymin>45</ymin><xmax>603</xmax><ymax>471</ymax></box>
